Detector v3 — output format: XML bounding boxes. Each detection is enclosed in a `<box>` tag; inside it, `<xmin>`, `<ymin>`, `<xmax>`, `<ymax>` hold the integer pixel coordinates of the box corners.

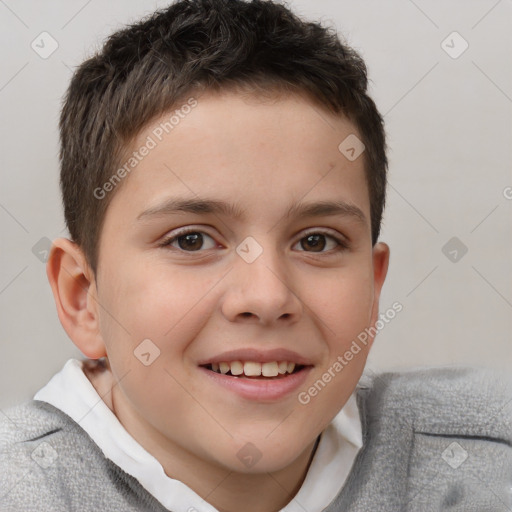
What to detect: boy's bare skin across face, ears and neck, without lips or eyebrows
<box><xmin>47</xmin><ymin>92</ymin><xmax>389</xmax><ymax>512</ymax></box>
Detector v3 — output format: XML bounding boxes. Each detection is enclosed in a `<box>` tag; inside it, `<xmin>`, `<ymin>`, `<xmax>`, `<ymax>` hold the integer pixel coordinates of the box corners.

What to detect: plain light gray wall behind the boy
<box><xmin>0</xmin><ymin>0</ymin><xmax>512</xmax><ymax>407</ymax></box>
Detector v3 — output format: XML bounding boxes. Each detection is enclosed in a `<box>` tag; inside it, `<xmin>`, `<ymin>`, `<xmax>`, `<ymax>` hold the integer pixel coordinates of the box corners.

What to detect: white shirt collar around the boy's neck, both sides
<box><xmin>34</xmin><ymin>359</ymin><xmax>363</xmax><ymax>512</ymax></box>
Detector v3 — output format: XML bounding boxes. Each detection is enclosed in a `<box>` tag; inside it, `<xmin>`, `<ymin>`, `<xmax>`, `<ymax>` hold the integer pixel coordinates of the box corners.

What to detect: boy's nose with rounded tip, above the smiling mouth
<box><xmin>222</xmin><ymin>243</ymin><xmax>303</xmax><ymax>325</ymax></box>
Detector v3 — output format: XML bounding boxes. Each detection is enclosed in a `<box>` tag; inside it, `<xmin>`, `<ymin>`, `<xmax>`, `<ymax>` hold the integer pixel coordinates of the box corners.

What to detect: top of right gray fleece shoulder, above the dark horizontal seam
<box><xmin>358</xmin><ymin>367</ymin><xmax>512</xmax><ymax>444</ymax></box>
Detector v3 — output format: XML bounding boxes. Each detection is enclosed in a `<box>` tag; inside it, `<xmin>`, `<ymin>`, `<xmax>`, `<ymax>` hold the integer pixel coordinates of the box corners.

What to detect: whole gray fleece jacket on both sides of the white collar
<box><xmin>0</xmin><ymin>368</ymin><xmax>512</xmax><ymax>512</ymax></box>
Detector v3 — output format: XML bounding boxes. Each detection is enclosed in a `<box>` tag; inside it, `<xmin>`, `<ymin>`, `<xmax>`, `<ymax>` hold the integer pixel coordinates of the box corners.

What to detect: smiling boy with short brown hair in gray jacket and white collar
<box><xmin>0</xmin><ymin>0</ymin><xmax>512</xmax><ymax>512</ymax></box>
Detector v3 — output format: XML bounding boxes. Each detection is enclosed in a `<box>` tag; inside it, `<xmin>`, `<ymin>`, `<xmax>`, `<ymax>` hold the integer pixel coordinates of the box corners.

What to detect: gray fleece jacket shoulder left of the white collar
<box><xmin>0</xmin><ymin>400</ymin><xmax>163</xmax><ymax>512</ymax></box>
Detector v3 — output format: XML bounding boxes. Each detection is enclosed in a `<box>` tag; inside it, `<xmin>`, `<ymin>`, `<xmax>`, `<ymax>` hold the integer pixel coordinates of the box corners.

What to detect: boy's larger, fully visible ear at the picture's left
<box><xmin>46</xmin><ymin>238</ymin><xmax>107</xmax><ymax>359</ymax></box>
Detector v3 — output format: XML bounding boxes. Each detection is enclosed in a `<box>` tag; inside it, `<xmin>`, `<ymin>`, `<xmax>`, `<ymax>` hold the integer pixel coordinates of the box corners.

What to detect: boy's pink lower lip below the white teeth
<box><xmin>199</xmin><ymin>366</ymin><xmax>312</xmax><ymax>402</ymax></box>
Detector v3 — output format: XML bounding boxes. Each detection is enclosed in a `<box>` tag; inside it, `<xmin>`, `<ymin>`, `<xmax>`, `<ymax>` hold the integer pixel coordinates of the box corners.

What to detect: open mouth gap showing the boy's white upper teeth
<box><xmin>200</xmin><ymin>361</ymin><xmax>310</xmax><ymax>380</ymax></box>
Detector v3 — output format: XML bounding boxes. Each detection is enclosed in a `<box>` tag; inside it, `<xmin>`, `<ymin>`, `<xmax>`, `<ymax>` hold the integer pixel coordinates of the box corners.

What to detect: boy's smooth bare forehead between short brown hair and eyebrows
<box><xmin>107</xmin><ymin>93</ymin><xmax>369</xmax><ymax>227</ymax></box>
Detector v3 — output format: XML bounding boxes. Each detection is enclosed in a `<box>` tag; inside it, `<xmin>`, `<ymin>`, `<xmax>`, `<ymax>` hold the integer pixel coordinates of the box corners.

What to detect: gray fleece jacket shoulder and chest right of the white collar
<box><xmin>337</xmin><ymin>368</ymin><xmax>512</xmax><ymax>512</ymax></box>
